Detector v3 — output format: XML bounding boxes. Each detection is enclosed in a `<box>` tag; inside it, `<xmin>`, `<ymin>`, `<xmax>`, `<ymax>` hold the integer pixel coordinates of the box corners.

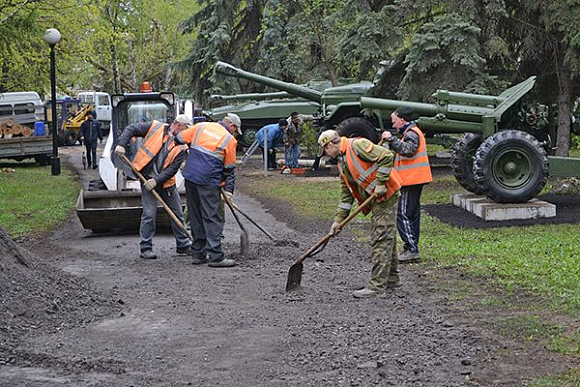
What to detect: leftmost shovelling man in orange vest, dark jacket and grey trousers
<box><xmin>115</xmin><ymin>114</ymin><xmax>192</xmax><ymax>259</ymax></box>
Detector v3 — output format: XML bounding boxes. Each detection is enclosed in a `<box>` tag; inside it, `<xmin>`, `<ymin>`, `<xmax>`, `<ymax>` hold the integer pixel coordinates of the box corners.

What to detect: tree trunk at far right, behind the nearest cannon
<box><xmin>556</xmin><ymin>58</ymin><xmax>572</xmax><ymax>157</ymax></box>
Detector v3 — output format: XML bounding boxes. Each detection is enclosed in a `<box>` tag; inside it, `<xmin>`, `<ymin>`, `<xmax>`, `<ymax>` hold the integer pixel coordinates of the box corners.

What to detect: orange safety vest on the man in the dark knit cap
<box><xmin>395</xmin><ymin>126</ymin><xmax>433</xmax><ymax>186</ymax></box>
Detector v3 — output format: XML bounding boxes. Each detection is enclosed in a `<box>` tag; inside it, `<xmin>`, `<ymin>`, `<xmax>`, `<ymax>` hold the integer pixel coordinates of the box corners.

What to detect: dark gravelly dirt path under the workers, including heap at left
<box><xmin>0</xmin><ymin>148</ymin><xmax>577</xmax><ymax>387</ymax></box>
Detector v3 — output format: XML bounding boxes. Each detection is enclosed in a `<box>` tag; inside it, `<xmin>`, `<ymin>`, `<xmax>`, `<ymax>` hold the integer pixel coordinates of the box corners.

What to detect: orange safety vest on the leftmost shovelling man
<box><xmin>133</xmin><ymin>121</ymin><xmax>186</xmax><ymax>188</ymax></box>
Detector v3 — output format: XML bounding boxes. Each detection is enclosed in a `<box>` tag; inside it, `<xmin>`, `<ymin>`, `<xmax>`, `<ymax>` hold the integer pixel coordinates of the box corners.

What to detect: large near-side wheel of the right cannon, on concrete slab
<box><xmin>473</xmin><ymin>130</ymin><xmax>548</xmax><ymax>203</ymax></box>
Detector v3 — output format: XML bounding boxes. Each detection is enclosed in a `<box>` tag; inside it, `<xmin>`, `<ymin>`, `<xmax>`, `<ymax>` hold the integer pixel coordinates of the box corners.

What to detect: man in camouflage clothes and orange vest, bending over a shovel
<box><xmin>318</xmin><ymin>130</ymin><xmax>401</xmax><ymax>298</ymax></box>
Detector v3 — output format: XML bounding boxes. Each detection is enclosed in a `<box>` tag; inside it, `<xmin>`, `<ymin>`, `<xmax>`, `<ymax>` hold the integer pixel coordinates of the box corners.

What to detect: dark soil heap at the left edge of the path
<box><xmin>0</xmin><ymin>228</ymin><xmax>120</xmax><ymax>365</ymax></box>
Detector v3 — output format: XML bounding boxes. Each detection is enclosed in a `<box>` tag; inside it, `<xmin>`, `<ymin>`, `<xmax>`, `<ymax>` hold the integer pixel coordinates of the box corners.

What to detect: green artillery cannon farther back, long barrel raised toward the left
<box><xmin>215</xmin><ymin>62</ymin><xmax>387</xmax><ymax>141</ymax></box>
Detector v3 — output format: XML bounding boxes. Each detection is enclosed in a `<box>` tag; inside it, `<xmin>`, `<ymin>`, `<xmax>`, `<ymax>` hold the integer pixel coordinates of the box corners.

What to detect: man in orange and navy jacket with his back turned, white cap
<box><xmin>177</xmin><ymin>113</ymin><xmax>242</xmax><ymax>267</ymax></box>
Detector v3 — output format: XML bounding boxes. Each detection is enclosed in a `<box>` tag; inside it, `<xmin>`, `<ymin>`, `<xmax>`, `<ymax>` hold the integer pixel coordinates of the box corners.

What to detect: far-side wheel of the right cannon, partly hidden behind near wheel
<box><xmin>451</xmin><ymin>133</ymin><xmax>483</xmax><ymax>195</ymax></box>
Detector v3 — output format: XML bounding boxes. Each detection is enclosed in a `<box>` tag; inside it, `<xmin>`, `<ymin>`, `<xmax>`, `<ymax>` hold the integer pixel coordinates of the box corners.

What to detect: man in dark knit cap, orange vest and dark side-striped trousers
<box><xmin>381</xmin><ymin>106</ymin><xmax>433</xmax><ymax>263</ymax></box>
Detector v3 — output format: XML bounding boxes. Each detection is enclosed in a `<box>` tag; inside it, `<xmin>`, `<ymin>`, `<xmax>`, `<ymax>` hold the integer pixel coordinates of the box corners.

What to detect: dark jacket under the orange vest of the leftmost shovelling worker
<box><xmin>117</xmin><ymin>122</ymin><xmax>187</xmax><ymax>185</ymax></box>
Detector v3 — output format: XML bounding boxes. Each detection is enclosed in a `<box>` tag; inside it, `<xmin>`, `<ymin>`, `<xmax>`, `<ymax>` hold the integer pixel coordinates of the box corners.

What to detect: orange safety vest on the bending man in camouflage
<box><xmin>338</xmin><ymin>137</ymin><xmax>402</xmax><ymax>215</ymax></box>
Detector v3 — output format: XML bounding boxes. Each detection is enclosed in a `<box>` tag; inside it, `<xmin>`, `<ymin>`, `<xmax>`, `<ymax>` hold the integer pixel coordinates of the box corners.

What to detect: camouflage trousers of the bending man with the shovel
<box><xmin>369</xmin><ymin>195</ymin><xmax>399</xmax><ymax>291</ymax></box>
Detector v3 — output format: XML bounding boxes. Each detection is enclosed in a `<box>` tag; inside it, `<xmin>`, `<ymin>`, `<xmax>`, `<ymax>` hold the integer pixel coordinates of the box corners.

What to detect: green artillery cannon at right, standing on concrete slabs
<box><xmin>360</xmin><ymin>77</ymin><xmax>580</xmax><ymax>203</ymax></box>
